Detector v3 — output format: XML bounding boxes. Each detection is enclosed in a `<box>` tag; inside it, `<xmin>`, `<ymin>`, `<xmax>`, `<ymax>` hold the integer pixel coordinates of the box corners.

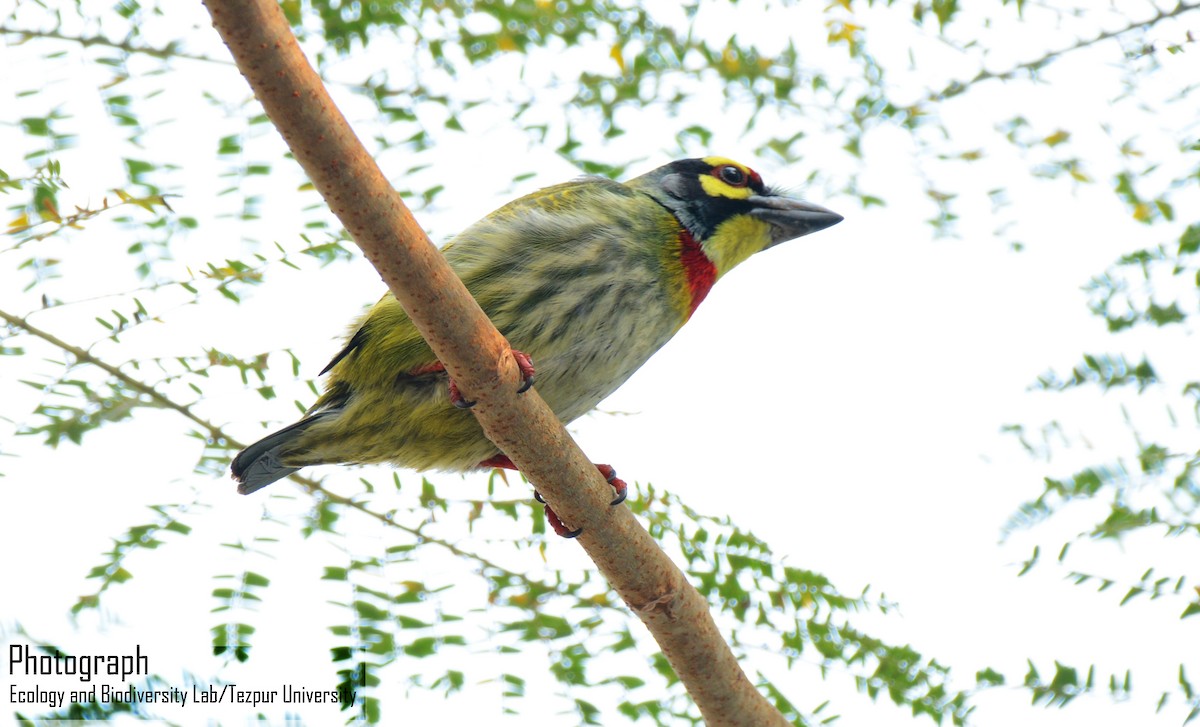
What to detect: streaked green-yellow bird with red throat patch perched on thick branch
<box><xmin>230</xmin><ymin>156</ymin><xmax>842</xmax><ymax>536</ymax></box>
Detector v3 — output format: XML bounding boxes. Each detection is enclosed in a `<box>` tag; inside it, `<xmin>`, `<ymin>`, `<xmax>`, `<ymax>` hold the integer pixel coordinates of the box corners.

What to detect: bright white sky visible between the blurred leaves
<box><xmin>0</xmin><ymin>2</ymin><xmax>1200</xmax><ymax>726</ymax></box>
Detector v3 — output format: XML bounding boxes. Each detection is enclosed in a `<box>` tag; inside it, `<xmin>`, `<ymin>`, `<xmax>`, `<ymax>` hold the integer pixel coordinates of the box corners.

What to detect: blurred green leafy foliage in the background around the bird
<box><xmin>0</xmin><ymin>0</ymin><xmax>1200</xmax><ymax>725</ymax></box>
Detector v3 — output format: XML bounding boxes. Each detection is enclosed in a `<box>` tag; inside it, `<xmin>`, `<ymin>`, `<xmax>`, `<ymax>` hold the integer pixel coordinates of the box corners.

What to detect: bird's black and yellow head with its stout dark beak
<box><xmin>629</xmin><ymin>156</ymin><xmax>842</xmax><ymax>275</ymax></box>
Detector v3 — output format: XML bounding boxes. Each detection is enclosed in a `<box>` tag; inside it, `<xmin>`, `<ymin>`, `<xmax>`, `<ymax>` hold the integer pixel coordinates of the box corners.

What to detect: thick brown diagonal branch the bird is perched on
<box><xmin>205</xmin><ymin>0</ymin><xmax>787</xmax><ymax>726</ymax></box>
